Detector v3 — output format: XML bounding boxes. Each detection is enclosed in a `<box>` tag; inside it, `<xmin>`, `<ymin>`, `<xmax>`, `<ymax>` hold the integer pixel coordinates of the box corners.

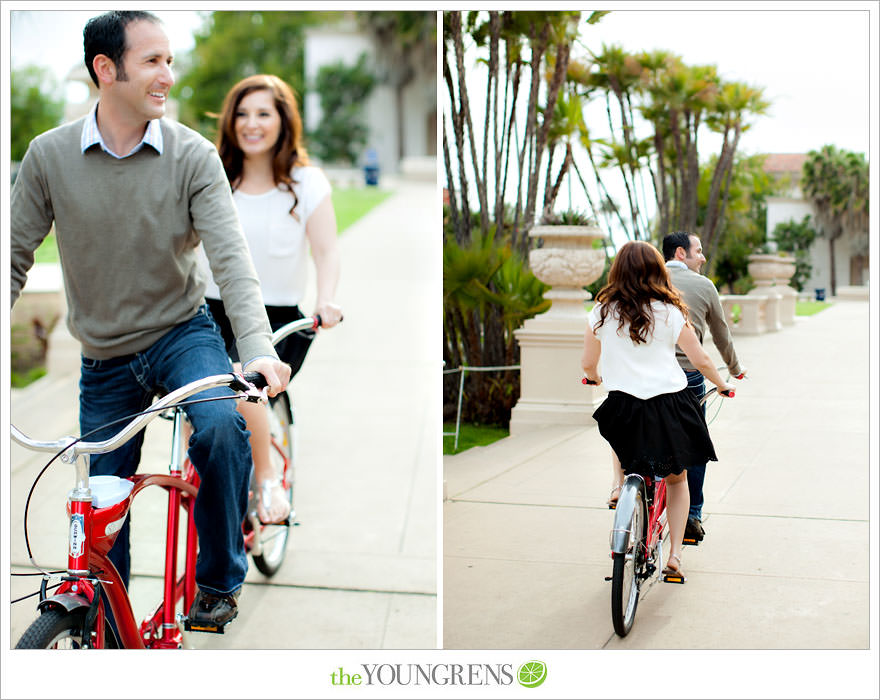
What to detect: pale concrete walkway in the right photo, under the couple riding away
<box><xmin>443</xmin><ymin>301</ymin><xmax>870</xmax><ymax>652</ymax></box>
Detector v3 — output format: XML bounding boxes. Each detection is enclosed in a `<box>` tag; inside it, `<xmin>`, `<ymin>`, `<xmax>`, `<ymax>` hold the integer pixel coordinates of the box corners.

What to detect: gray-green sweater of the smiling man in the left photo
<box><xmin>10</xmin><ymin>119</ymin><xmax>275</xmax><ymax>362</ymax></box>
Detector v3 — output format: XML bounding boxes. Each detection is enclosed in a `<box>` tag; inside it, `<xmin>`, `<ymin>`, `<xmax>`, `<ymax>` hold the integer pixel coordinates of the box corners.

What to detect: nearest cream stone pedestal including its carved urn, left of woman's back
<box><xmin>510</xmin><ymin>226</ymin><xmax>605</xmax><ymax>435</ymax></box>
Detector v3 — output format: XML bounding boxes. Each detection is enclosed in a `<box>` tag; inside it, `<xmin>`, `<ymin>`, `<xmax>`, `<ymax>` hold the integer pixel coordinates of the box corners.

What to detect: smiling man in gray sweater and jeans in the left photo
<box><xmin>10</xmin><ymin>11</ymin><xmax>290</xmax><ymax>627</ymax></box>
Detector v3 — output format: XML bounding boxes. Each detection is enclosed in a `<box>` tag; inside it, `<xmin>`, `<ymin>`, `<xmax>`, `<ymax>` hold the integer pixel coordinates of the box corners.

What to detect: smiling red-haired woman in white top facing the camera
<box><xmin>203</xmin><ymin>75</ymin><xmax>342</xmax><ymax>523</ymax></box>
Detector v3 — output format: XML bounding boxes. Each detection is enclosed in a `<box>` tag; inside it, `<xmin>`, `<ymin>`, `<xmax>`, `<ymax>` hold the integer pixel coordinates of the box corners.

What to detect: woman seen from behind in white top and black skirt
<box><xmin>581</xmin><ymin>241</ymin><xmax>733</xmax><ymax>576</ymax></box>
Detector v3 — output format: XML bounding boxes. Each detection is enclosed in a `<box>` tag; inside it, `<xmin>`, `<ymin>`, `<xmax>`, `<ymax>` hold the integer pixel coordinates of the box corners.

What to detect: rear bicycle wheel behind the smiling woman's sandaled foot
<box><xmin>253</xmin><ymin>393</ymin><xmax>295</xmax><ymax>576</ymax></box>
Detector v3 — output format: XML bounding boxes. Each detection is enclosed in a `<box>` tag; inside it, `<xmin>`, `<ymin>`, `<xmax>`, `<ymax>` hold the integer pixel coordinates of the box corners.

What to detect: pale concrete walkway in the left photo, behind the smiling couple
<box><xmin>10</xmin><ymin>180</ymin><xmax>441</xmax><ymax>649</ymax></box>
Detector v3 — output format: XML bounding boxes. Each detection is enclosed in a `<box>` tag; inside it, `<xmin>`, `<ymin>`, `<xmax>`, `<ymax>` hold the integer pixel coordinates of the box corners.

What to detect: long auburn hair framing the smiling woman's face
<box><xmin>216</xmin><ymin>74</ymin><xmax>309</xmax><ymax>218</ymax></box>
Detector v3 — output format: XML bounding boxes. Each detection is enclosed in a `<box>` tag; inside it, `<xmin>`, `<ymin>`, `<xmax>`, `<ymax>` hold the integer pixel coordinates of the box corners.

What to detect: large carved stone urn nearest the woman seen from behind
<box><xmin>529</xmin><ymin>225</ymin><xmax>605</xmax><ymax>318</ymax></box>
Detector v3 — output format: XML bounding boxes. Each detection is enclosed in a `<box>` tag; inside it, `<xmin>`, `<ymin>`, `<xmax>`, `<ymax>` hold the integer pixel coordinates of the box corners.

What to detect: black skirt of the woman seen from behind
<box><xmin>593</xmin><ymin>389</ymin><xmax>718</xmax><ymax>477</ymax></box>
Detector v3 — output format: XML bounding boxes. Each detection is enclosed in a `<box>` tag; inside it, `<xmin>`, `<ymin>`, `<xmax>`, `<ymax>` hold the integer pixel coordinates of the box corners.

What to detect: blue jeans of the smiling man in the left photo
<box><xmin>80</xmin><ymin>306</ymin><xmax>253</xmax><ymax>594</ymax></box>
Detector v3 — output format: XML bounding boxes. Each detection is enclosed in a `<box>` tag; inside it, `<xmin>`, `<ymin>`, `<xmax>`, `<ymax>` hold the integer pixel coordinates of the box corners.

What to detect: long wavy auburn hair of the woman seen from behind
<box><xmin>593</xmin><ymin>241</ymin><xmax>688</xmax><ymax>344</ymax></box>
